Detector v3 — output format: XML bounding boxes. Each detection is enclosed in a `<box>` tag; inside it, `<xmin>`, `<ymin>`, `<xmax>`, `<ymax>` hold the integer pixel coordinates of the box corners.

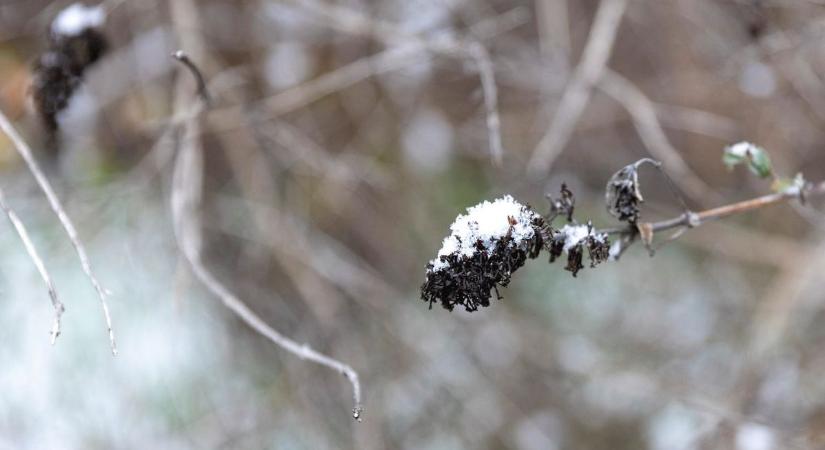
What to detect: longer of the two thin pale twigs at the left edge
<box><xmin>0</xmin><ymin>110</ymin><xmax>117</xmax><ymax>355</ymax></box>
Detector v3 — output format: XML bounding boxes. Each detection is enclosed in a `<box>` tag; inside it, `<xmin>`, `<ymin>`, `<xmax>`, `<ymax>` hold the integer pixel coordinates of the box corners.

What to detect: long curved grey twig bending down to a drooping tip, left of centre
<box><xmin>171</xmin><ymin>48</ymin><xmax>363</xmax><ymax>421</ymax></box>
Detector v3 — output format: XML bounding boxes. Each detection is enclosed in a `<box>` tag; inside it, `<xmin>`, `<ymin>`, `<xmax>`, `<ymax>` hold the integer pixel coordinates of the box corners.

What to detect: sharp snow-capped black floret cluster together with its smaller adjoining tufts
<box><xmin>421</xmin><ymin>190</ymin><xmax>610</xmax><ymax>311</ymax></box>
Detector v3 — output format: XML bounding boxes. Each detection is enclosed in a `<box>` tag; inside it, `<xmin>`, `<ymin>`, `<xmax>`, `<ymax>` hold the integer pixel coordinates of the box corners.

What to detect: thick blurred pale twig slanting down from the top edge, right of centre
<box><xmin>528</xmin><ymin>0</ymin><xmax>627</xmax><ymax>175</ymax></box>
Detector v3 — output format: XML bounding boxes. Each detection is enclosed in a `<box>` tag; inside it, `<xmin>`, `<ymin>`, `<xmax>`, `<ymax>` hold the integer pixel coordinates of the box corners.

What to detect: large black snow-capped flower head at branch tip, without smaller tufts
<box><xmin>421</xmin><ymin>195</ymin><xmax>548</xmax><ymax>311</ymax></box>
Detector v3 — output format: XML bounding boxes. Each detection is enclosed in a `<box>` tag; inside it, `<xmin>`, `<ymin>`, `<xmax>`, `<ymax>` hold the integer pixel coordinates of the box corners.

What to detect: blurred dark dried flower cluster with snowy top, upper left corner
<box><xmin>32</xmin><ymin>3</ymin><xmax>108</xmax><ymax>132</ymax></box>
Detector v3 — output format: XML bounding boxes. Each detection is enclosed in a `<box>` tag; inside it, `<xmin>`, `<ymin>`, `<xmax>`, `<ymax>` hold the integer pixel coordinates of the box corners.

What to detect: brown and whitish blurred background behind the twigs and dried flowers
<box><xmin>0</xmin><ymin>0</ymin><xmax>825</xmax><ymax>450</ymax></box>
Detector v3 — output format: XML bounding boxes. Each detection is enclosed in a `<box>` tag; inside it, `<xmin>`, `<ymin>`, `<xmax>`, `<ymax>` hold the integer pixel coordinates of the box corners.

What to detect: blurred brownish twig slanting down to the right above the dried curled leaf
<box><xmin>598</xmin><ymin>69</ymin><xmax>719</xmax><ymax>201</ymax></box>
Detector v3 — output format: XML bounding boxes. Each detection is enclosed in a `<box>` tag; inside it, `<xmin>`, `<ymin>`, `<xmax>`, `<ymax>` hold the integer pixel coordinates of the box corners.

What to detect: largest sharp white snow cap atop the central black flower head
<box><xmin>430</xmin><ymin>195</ymin><xmax>541</xmax><ymax>272</ymax></box>
